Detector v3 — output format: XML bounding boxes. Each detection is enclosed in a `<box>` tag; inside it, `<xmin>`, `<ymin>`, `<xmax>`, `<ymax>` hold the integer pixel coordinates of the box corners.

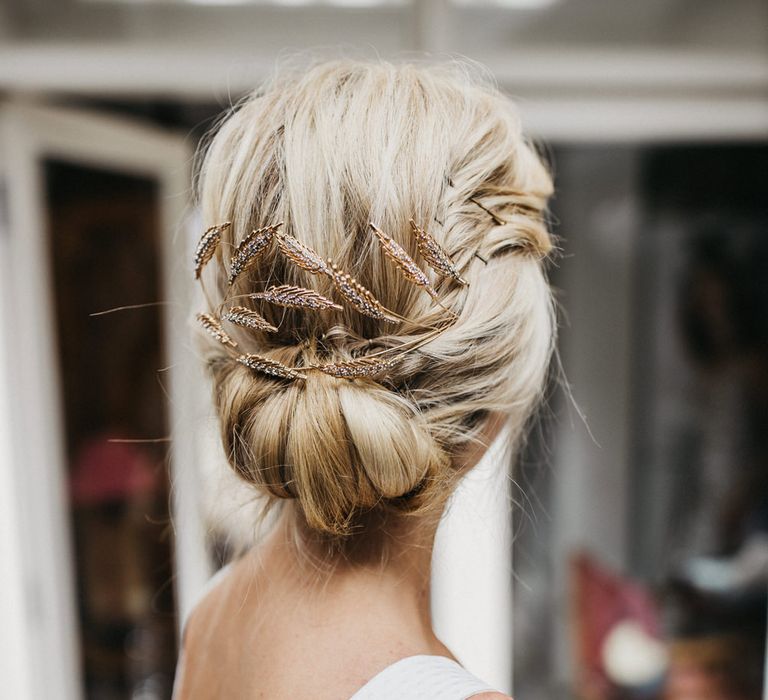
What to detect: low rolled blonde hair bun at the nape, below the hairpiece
<box><xmin>214</xmin><ymin>362</ymin><xmax>451</xmax><ymax>536</ymax></box>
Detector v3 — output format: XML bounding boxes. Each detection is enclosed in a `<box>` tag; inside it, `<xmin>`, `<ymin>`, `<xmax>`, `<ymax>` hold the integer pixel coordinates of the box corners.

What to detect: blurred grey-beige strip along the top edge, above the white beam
<box><xmin>0</xmin><ymin>0</ymin><xmax>768</xmax><ymax>52</ymax></box>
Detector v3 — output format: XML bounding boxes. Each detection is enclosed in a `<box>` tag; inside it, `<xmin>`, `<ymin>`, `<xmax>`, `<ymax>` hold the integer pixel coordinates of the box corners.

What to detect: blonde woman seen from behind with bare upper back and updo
<box><xmin>176</xmin><ymin>60</ymin><xmax>554</xmax><ymax>700</ymax></box>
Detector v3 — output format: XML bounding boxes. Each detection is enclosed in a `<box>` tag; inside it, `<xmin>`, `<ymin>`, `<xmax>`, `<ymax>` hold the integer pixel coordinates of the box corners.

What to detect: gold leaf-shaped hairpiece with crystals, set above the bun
<box><xmin>194</xmin><ymin>196</ymin><xmax>528</xmax><ymax>380</ymax></box>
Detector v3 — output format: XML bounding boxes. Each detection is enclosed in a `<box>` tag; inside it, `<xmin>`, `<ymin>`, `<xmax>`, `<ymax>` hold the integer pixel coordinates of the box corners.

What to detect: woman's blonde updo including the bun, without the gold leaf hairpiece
<box><xmin>199</xmin><ymin>60</ymin><xmax>555</xmax><ymax>542</ymax></box>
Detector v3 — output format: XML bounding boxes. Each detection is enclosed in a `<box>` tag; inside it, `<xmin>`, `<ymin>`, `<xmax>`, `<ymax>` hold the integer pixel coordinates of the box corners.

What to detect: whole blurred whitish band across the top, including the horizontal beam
<box><xmin>0</xmin><ymin>0</ymin><xmax>768</xmax><ymax>138</ymax></box>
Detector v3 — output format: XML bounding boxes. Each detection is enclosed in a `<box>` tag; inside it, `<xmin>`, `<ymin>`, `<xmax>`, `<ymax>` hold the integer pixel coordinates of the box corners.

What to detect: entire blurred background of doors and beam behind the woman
<box><xmin>0</xmin><ymin>0</ymin><xmax>768</xmax><ymax>700</ymax></box>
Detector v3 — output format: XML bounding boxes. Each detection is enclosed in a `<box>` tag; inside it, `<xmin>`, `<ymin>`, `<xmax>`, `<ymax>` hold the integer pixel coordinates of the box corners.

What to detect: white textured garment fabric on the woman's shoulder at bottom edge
<box><xmin>350</xmin><ymin>655</ymin><xmax>493</xmax><ymax>700</ymax></box>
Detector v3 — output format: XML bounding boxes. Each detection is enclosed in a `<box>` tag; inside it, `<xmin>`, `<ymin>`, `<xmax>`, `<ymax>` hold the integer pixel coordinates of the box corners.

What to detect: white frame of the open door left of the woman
<box><xmin>0</xmin><ymin>102</ymin><xmax>209</xmax><ymax>700</ymax></box>
